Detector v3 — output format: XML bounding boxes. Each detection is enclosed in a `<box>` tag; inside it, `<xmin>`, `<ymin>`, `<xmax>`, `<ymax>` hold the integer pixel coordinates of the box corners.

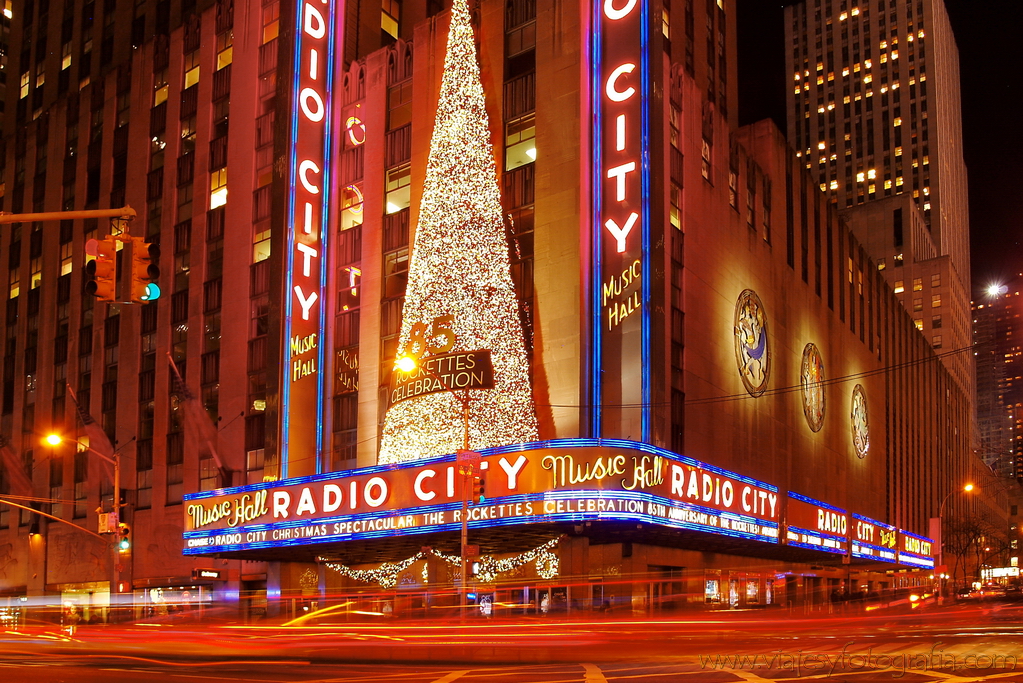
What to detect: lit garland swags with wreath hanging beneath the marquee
<box><xmin>319</xmin><ymin>536</ymin><xmax>564</xmax><ymax>589</ymax></box>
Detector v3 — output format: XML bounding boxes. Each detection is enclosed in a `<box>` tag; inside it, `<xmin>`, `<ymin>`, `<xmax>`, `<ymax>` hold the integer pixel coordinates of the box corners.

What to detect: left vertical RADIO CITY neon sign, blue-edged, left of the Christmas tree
<box><xmin>280</xmin><ymin>0</ymin><xmax>344</xmax><ymax>476</ymax></box>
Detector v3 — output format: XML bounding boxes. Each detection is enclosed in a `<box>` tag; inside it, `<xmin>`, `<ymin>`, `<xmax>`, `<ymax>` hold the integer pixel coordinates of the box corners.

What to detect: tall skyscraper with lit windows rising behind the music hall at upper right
<box><xmin>785</xmin><ymin>0</ymin><xmax>973</xmax><ymax>393</ymax></box>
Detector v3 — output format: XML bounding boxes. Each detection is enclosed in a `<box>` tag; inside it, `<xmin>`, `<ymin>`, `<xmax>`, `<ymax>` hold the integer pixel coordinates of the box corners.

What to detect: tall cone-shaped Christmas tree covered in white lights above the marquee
<box><xmin>380</xmin><ymin>0</ymin><xmax>538</xmax><ymax>463</ymax></box>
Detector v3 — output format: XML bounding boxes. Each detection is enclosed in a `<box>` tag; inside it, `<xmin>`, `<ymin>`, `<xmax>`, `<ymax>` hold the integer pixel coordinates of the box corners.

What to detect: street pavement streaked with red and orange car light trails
<box><xmin>0</xmin><ymin>602</ymin><xmax>1023</xmax><ymax>683</ymax></box>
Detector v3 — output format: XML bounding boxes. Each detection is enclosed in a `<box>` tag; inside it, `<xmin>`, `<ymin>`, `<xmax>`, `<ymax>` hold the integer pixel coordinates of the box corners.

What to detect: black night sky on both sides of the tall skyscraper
<box><xmin>738</xmin><ymin>0</ymin><xmax>1023</xmax><ymax>297</ymax></box>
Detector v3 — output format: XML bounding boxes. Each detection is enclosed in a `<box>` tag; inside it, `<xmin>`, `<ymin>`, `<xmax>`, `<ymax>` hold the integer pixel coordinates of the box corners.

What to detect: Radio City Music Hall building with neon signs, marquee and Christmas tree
<box><xmin>0</xmin><ymin>0</ymin><xmax>977</xmax><ymax>613</ymax></box>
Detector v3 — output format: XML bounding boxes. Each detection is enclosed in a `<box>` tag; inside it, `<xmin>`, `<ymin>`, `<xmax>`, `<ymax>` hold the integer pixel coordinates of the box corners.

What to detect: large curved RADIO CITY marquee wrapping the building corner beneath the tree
<box><xmin>184</xmin><ymin>439</ymin><xmax>781</xmax><ymax>554</ymax></box>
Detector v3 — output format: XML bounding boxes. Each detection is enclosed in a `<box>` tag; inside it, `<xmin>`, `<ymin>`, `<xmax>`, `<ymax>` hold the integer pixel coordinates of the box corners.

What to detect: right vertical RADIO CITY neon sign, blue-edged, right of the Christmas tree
<box><xmin>590</xmin><ymin>0</ymin><xmax>651</xmax><ymax>441</ymax></box>
